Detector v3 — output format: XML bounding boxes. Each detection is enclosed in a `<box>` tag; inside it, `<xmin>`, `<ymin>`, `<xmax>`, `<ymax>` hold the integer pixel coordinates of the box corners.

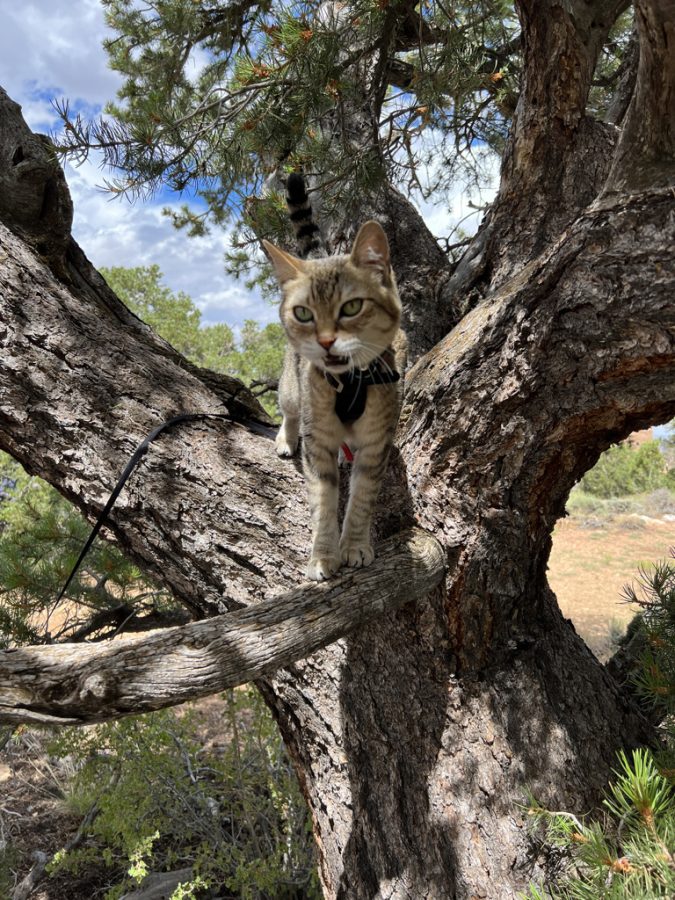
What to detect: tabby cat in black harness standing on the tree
<box><xmin>263</xmin><ymin>174</ymin><xmax>405</xmax><ymax>581</ymax></box>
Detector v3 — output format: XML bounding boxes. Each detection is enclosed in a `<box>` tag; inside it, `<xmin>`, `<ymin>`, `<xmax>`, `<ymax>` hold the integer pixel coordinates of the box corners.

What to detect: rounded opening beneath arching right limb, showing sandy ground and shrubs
<box><xmin>549</xmin><ymin>426</ymin><xmax>675</xmax><ymax>662</ymax></box>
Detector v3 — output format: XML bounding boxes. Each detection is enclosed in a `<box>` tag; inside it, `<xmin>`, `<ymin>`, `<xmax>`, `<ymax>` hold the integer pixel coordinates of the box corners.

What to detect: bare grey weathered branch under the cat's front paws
<box><xmin>0</xmin><ymin>529</ymin><xmax>445</xmax><ymax>725</ymax></box>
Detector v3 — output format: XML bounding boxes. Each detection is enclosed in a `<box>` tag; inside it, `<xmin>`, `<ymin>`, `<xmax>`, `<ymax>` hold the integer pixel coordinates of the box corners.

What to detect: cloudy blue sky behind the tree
<box><xmin>0</xmin><ymin>0</ymin><xmax>491</xmax><ymax>330</ymax></box>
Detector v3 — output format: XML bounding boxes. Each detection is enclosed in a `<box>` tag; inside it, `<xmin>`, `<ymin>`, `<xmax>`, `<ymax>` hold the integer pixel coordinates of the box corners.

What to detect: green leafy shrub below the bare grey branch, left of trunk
<box><xmin>50</xmin><ymin>688</ymin><xmax>321</xmax><ymax>900</ymax></box>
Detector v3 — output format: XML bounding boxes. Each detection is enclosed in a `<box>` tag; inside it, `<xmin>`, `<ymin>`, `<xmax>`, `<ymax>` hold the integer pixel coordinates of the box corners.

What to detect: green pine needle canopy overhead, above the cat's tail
<box><xmin>55</xmin><ymin>0</ymin><xmax>520</xmax><ymax>251</ymax></box>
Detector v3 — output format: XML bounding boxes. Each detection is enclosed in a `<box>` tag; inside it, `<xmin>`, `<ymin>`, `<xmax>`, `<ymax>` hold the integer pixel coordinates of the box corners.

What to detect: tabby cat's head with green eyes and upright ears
<box><xmin>263</xmin><ymin>222</ymin><xmax>401</xmax><ymax>374</ymax></box>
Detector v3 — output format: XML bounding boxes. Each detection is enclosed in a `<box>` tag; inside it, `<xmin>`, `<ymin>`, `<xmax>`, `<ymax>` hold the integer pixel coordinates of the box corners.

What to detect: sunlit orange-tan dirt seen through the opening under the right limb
<box><xmin>548</xmin><ymin>515</ymin><xmax>675</xmax><ymax>659</ymax></box>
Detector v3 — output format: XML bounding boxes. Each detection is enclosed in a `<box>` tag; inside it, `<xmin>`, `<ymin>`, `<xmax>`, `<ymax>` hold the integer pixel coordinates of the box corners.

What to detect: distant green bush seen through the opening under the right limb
<box><xmin>579</xmin><ymin>441</ymin><xmax>675</xmax><ymax>498</ymax></box>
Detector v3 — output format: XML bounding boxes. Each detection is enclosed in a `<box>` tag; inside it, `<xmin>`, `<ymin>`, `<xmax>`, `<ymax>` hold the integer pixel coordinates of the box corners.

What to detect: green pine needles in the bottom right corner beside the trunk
<box><xmin>526</xmin><ymin>561</ymin><xmax>675</xmax><ymax>900</ymax></box>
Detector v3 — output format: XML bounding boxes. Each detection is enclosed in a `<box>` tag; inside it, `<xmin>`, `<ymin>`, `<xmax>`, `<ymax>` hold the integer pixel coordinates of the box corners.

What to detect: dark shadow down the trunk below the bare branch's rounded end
<box><xmin>337</xmin><ymin>591</ymin><xmax>456</xmax><ymax>898</ymax></box>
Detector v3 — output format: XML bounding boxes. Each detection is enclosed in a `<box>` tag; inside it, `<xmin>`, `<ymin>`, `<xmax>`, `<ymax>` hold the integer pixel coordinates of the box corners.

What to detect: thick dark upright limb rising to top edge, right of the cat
<box><xmin>443</xmin><ymin>0</ymin><xmax>628</xmax><ymax>324</ymax></box>
